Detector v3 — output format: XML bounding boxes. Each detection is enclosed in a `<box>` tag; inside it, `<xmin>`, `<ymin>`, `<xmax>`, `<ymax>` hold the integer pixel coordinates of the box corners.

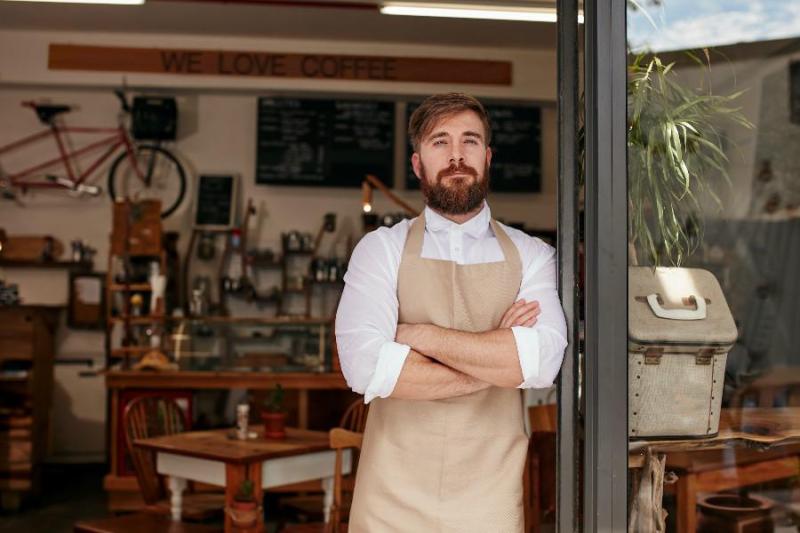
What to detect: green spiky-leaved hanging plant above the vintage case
<box><xmin>627</xmin><ymin>54</ymin><xmax>752</xmax><ymax>266</ymax></box>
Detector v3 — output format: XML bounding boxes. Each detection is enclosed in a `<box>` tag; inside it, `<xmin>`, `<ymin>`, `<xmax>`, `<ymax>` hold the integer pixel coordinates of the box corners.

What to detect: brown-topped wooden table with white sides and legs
<box><xmin>135</xmin><ymin>426</ymin><xmax>351</xmax><ymax>533</ymax></box>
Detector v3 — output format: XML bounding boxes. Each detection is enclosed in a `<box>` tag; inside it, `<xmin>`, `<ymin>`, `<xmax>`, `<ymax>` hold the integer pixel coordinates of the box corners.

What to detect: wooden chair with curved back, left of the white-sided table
<box><xmin>123</xmin><ymin>396</ymin><xmax>225</xmax><ymax>521</ymax></box>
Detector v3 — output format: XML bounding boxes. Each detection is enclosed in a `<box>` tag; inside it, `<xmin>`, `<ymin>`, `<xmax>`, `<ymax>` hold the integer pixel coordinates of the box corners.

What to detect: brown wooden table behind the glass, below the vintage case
<box><xmin>629</xmin><ymin>407</ymin><xmax>800</xmax><ymax>533</ymax></box>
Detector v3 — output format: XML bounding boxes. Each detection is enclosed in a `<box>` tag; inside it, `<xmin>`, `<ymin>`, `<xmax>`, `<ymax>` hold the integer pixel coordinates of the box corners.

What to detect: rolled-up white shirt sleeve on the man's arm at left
<box><xmin>335</xmin><ymin>230</ymin><xmax>410</xmax><ymax>403</ymax></box>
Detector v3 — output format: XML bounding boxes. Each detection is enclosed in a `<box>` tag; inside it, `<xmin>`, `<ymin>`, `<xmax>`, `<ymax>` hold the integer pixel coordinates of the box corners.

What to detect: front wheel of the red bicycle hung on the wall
<box><xmin>108</xmin><ymin>145</ymin><xmax>186</xmax><ymax>218</ymax></box>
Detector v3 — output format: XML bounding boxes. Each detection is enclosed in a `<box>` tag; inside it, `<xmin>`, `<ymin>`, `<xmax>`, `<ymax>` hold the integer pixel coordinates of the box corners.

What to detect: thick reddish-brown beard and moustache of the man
<box><xmin>420</xmin><ymin>162</ymin><xmax>489</xmax><ymax>215</ymax></box>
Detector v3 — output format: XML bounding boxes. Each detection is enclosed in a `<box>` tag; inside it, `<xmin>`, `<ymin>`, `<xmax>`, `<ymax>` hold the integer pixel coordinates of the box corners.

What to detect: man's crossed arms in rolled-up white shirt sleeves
<box><xmin>336</xmin><ymin>230</ymin><xmax>566</xmax><ymax>402</ymax></box>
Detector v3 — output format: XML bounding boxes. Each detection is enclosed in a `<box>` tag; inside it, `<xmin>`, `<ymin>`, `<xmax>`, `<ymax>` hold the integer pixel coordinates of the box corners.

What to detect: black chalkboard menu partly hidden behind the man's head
<box><xmin>406</xmin><ymin>103</ymin><xmax>542</xmax><ymax>192</ymax></box>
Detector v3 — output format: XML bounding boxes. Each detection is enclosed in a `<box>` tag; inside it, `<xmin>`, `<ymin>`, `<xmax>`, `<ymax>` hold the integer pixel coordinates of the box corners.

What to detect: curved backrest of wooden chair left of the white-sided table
<box><xmin>123</xmin><ymin>396</ymin><xmax>188</xmax><ymax>505</ymax></box>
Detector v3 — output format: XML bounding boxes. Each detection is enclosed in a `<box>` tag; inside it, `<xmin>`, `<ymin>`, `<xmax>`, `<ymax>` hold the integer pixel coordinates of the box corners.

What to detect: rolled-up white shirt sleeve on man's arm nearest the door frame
<box><xmin>511</xmin><ymin>240</ymin><xmax>567</xmax><ymax>389</ymax></box>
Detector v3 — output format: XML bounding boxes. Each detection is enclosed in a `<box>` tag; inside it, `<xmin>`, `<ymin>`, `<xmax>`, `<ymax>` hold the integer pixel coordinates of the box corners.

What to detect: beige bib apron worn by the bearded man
<box><xmin>349</xmin><ymin>214</ymin><xmax>527</xmax><ymax>533</ymax></box>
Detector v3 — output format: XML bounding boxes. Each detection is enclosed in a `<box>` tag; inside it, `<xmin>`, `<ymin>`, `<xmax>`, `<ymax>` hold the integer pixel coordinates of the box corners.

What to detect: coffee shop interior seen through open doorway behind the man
<box><xmin>0</xmin><ymin>0</ymin><xmax>556</xmax><ymax>532</ymax></box>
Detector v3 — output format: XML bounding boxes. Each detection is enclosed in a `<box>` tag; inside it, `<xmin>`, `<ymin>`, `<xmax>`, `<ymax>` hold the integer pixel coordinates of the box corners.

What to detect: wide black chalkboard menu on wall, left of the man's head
<box><xmin>256</xmin><ymin>98</ymin><xmax>394</xmax><ymax>187</ymax></box>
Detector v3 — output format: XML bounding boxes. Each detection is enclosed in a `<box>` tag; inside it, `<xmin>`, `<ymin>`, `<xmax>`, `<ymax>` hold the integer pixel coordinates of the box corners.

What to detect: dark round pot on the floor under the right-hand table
<box><xmin>697</xmin><ymin>494</ymin><xmax>775</xmax><ymax>533</ymax></box>
